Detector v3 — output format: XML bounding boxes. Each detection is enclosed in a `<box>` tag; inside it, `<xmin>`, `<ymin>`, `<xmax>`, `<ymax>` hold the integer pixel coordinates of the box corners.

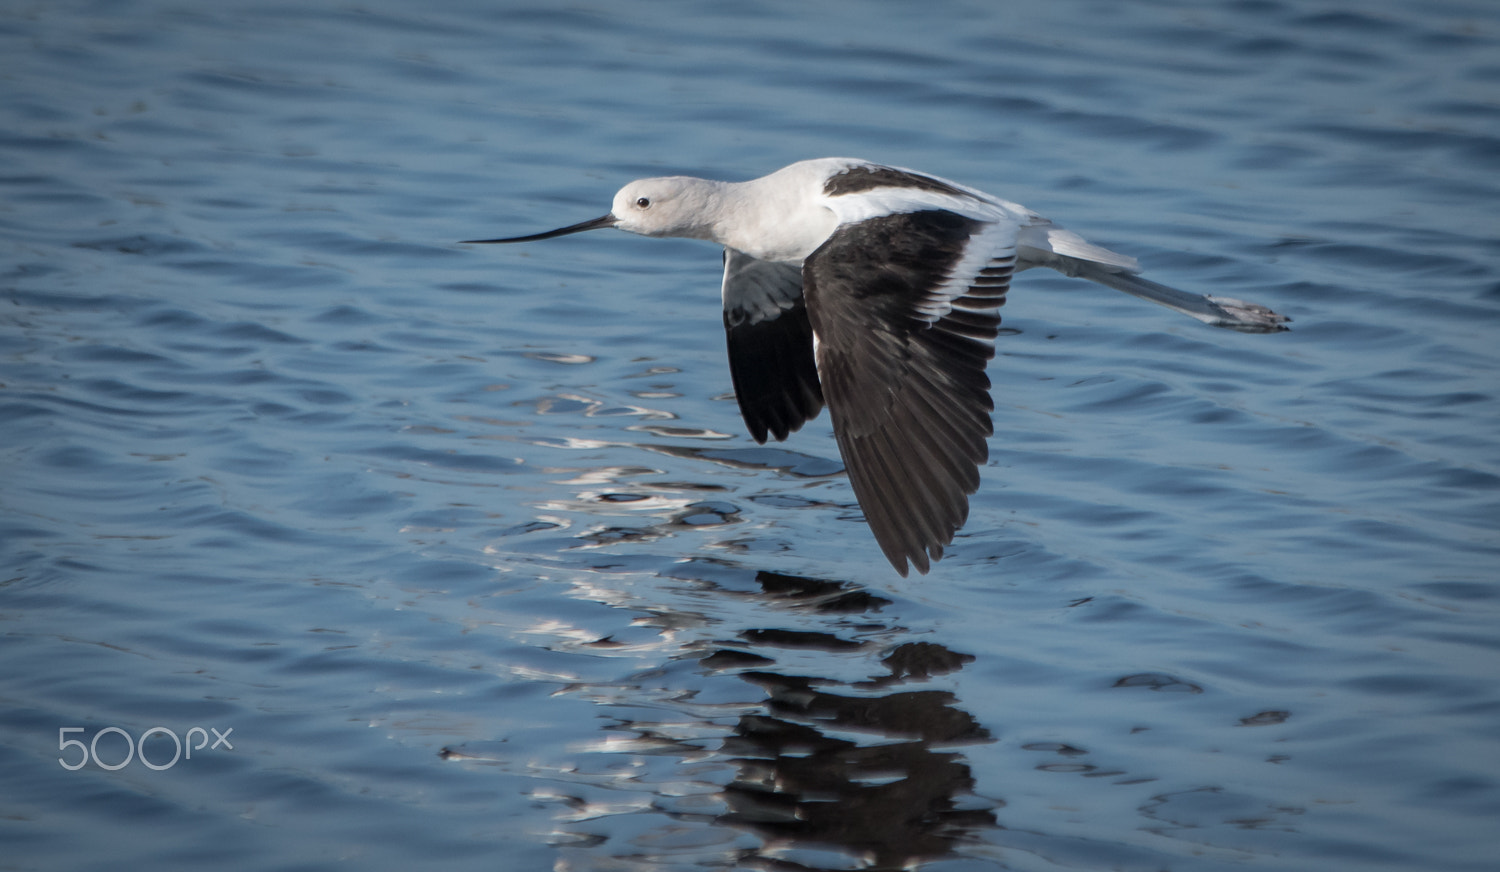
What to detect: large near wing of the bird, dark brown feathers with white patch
<box><xmin>803</xmin><ymin>209</ymin><xmax>1019</xmax><ymax>575</ymax></box>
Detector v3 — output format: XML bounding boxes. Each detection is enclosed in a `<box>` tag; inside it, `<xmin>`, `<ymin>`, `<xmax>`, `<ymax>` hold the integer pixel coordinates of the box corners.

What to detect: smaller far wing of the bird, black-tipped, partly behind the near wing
<box><xmin>725</xmin><ymin>248</ymin><xmax>824</xmax><ymax>443</ymax></box>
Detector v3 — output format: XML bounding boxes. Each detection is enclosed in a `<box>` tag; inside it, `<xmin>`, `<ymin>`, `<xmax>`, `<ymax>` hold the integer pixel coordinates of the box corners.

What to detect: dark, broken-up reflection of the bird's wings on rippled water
<box><xmin>702</xmin><ymin>572</ymin><xmax>999</xmax><ymax>869</ymax></box>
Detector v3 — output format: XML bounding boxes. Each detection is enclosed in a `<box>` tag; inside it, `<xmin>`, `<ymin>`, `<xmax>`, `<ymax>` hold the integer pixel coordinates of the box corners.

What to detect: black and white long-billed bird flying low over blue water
<box><xmin>464</xmin><ymin>158</ymin><xmax>1290</xmax><ymax>578</ymax></box>
